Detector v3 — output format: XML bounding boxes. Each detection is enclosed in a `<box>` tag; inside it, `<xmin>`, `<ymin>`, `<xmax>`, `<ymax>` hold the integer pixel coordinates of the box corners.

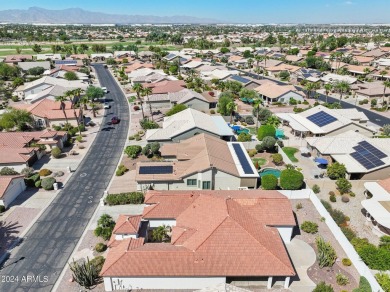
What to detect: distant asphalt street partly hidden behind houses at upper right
<box><xmin>228</xmin><ymin>67</ymin><xmax>390</xmax><ymax>127</ymax></box>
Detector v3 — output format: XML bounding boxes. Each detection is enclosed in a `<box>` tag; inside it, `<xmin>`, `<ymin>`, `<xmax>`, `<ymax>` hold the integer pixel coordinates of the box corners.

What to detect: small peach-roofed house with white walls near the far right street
<box><xmin>254</xmin><ymin>82</ymin><xmax>305</xmax><ymax>103</ymax></box>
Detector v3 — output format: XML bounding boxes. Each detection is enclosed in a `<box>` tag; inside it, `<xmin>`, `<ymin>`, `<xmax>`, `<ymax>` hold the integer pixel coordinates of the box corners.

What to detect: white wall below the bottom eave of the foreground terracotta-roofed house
<box><xmin>103</xmin><ymin>277</ymin><xmax>226</xmax><ymax>291</ymax></box>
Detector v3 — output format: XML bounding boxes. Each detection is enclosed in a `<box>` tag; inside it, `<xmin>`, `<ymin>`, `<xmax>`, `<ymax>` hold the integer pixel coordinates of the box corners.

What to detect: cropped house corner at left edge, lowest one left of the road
<box><xmin>0</xmin><ymin>175</ymin><xmax>26</xmax><ymax>208</ymax></box>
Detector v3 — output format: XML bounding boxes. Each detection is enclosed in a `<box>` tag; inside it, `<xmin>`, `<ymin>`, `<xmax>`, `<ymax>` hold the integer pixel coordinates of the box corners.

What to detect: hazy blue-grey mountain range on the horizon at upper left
<box><xmin>0</xmin><ymin>7</ymin><xmax>220</xmax><ymax>24</ymax></box>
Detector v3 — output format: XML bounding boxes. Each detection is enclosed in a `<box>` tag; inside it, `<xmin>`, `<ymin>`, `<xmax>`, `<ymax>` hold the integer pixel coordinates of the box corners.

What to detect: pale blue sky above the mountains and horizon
<box><xmin>0</xmin><ymin>0</ymin><xmax>390</xmax><ymax>23</ymax></box>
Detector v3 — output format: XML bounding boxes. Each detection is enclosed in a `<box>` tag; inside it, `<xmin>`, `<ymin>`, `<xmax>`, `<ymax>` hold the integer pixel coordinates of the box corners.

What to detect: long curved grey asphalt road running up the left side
<box><xmin>0</xmin><ymin>65</ymin><xmax>129</xmax><ymax>292</ymax></box>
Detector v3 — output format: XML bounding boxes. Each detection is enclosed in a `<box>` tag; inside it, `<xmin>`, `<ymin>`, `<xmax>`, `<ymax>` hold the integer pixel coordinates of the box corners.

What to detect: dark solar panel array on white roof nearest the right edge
<box><xmin>351</xmin><ymin>141</ymin><xmax>387</xmax><ymax>169</ymax></box>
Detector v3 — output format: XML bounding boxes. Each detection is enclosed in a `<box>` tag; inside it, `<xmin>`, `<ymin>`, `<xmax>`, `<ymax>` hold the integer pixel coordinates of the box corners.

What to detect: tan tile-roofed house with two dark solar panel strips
<box><xmin>135</xmin><ymin>133</ymin><xmax>259</xmax><ymax>190</ymax></box>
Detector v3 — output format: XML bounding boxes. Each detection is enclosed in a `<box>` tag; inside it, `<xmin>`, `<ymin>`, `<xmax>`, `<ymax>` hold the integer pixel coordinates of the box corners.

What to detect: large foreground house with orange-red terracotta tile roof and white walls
<box><xmin>101</xmin><ymin>191</ymin><xmax>296</xmax><ymax>291</ymax></box>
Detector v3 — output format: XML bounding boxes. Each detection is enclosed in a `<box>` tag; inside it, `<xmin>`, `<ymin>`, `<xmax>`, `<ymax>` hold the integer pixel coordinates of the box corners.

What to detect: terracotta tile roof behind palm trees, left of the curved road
<box><xmin>13</xmin><ymin>99</ymin><xmax>80</xmax><ymax>120</ymax></box>
